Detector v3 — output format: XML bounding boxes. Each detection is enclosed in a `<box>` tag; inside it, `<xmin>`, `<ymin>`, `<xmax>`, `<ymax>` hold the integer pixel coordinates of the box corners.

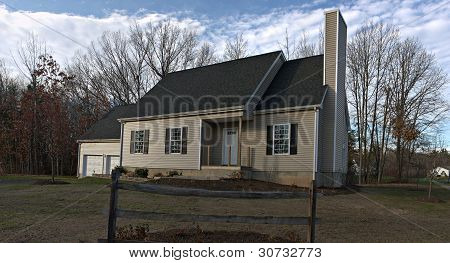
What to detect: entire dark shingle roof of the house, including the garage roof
<box><xmin>80</xmin><ymin>51</ymin><xmax>327</xmax><ymax>140</ymax></box>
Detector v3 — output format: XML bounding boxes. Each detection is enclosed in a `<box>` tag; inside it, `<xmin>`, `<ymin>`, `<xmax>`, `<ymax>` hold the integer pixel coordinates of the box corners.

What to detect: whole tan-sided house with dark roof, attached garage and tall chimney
<box><xmin>78</xmin><ymin>10</ymin><xmax>349</xmax><ymax>186</ymax></box>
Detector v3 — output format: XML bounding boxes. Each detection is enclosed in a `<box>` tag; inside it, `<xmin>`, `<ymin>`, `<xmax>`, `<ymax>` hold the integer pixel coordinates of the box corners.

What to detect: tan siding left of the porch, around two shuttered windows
<box><xmin>123</xmin><ymin>112</ymin><xmax>242</xmax><ymax>169</ymax></box>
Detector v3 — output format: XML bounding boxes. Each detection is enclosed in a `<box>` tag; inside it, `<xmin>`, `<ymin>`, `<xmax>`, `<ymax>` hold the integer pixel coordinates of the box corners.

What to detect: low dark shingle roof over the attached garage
<box><xmin>79</xmin><ymin>104</ymin><xmax>136</xmax><ymax>140</ymax></box>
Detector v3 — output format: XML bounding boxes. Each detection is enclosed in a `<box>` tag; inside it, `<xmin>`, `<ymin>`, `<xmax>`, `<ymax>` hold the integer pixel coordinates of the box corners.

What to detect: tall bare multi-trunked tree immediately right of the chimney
<box><xmin>347</xmin><ymin>22</ymin><xmax>398</xmax><ymax>183</ymax></box>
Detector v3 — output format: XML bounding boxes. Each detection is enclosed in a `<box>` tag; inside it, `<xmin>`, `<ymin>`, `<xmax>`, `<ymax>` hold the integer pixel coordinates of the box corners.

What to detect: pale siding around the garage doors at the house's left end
<box><xmin>78</xmin><ymin>141</ymin><xmax>120</xmax><ymax>176</ymax></box>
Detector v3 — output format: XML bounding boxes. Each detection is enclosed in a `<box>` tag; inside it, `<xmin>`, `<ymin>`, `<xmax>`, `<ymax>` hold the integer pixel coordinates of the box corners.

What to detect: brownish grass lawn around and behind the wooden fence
<box><xmin>0</xmin><ymin>175</ymin><xmax>450</xmax><ymax>242</ymax></box>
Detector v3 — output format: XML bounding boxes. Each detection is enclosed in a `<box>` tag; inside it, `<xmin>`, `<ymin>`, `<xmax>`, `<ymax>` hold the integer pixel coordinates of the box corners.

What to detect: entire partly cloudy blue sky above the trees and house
<box><xmin>0</xmin><ymin>0</ymin><xmax>450</xmax><ymax>144</ymax></box>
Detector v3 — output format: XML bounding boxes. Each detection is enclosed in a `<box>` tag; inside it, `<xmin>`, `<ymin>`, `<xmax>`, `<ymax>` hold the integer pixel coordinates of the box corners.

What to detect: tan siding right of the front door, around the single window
<box><xmin>241</xmin><ymin>110</ymin><xmax>314</xmax><ymax>175</ymax></box>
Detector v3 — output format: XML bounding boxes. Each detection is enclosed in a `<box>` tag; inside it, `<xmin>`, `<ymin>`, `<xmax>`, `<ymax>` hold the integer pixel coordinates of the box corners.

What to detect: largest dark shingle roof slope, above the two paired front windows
<box><xmin>139</xmin><ymin>51</ymin><xmax>281</xmax><ymax>116</ymax></box>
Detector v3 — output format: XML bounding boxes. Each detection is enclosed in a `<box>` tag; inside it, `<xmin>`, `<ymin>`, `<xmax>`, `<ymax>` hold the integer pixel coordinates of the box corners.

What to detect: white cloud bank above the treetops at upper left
<box><xmin>0</xmin><ymin>5</ymin><xmax>205</xmax><ymax>75</ymax></box>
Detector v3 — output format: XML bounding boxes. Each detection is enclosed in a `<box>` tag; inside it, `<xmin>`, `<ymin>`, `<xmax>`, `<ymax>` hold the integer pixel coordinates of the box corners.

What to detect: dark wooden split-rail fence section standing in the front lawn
<box><xmin>107</xmin><ymin>170</ymin><xmax>318</xmax><ymax>243</ymax></box>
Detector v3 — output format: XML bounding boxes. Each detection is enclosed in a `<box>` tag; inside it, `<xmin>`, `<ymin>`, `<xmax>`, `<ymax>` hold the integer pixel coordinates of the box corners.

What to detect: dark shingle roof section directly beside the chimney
<box><xmin>257</xmin><ymin>55</ymin><xmax>327</xmax><ymax>109</ymax></box>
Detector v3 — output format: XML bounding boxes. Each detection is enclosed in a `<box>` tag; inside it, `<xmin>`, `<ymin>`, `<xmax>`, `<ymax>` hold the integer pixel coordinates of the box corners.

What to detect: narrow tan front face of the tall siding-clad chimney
<box><xmin>320</xmin><ymin>12</ymin><xmax>338</xmax><ymax>172</ymax></box>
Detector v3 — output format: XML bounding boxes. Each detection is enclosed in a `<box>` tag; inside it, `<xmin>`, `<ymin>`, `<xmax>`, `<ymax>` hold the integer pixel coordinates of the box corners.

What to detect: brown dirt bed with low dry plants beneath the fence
<box><xmin>117</xmin><ymin>225</ymin><xmax>305</xmax><ymax>243</ymax></box>
